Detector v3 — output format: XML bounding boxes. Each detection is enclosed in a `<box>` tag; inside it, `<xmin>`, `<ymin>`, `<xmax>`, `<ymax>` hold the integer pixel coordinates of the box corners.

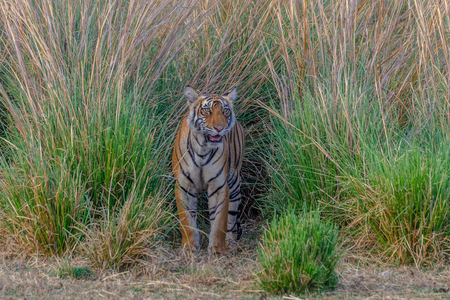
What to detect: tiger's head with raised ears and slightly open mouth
<box><xmin>184</xmin><ymin>86</ymin><xmax>237</xmax><ymax>145</ymax></box>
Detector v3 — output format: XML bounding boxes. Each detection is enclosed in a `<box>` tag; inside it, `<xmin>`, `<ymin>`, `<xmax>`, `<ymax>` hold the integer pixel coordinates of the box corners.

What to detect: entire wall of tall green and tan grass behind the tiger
<box><xmin>0</xmin><ymin>0</ymin><xmax>450</xmax><ymax>276</ymax></box>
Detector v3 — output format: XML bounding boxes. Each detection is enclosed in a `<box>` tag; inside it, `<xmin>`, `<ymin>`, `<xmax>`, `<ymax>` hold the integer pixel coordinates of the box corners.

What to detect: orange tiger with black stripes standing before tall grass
<box><xmin>172</xmin><ymin>86</ymin><xmax>245</xmax><ymax>254</ymax></box>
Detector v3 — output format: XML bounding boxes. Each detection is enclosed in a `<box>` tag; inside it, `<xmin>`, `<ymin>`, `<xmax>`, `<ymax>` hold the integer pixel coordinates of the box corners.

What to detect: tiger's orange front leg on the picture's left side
<box><xmin>175</xmin><ymin>182</ymin><xmax>200</xmax><ymax>251</ymax></box>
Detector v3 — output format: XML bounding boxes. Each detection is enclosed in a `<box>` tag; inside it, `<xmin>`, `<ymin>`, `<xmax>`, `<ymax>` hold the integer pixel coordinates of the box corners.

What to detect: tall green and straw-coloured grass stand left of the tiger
<box><xmin>1</xmin><ymin>1</ymin><xmax>195</xmax><ymax>265</ymax></box>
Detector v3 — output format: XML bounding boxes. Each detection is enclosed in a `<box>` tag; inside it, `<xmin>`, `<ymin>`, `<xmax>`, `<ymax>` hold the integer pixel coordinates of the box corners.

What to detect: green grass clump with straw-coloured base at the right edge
<box><xmin>348</xmin><ymin>142</ymin><xmax>450</xmax><ymax>266</ymax></box>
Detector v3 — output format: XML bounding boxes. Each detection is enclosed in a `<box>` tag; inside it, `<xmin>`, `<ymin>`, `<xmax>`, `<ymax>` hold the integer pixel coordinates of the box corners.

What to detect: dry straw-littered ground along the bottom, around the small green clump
<box><xmin>0</xmin><ymin>221</ymin><xmax>450</xmax><ymax>300</ymax></box>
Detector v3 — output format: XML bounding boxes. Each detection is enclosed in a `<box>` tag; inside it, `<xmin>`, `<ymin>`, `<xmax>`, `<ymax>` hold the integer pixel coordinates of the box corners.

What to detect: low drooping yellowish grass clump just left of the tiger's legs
<box><xmin>81</xmin><ymin>190</ymin><xmax>170</xmax><ymax>270</ymax></box>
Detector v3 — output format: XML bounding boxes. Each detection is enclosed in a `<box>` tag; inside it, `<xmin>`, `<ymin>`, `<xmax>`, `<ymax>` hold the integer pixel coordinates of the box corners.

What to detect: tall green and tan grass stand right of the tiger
<box><xmin>263</xmin><ymin>0</ymin><xmax>450</xmax><ymax>265</ymax></box>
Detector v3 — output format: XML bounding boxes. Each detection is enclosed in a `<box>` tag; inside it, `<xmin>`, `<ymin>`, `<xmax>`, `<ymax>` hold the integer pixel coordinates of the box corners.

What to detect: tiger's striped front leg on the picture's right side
<box><xmin>208</xmin><ymin>180</ymin><xmax>230</xmax><ymax>254</ymax></box>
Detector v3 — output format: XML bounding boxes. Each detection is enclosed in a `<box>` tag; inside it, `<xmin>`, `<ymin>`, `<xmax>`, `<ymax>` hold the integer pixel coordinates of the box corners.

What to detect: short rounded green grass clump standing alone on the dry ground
<box><xmin>258</xmin><ymin>212</ymin><xmax>340</xmax><ymax>294</ymax></box>
